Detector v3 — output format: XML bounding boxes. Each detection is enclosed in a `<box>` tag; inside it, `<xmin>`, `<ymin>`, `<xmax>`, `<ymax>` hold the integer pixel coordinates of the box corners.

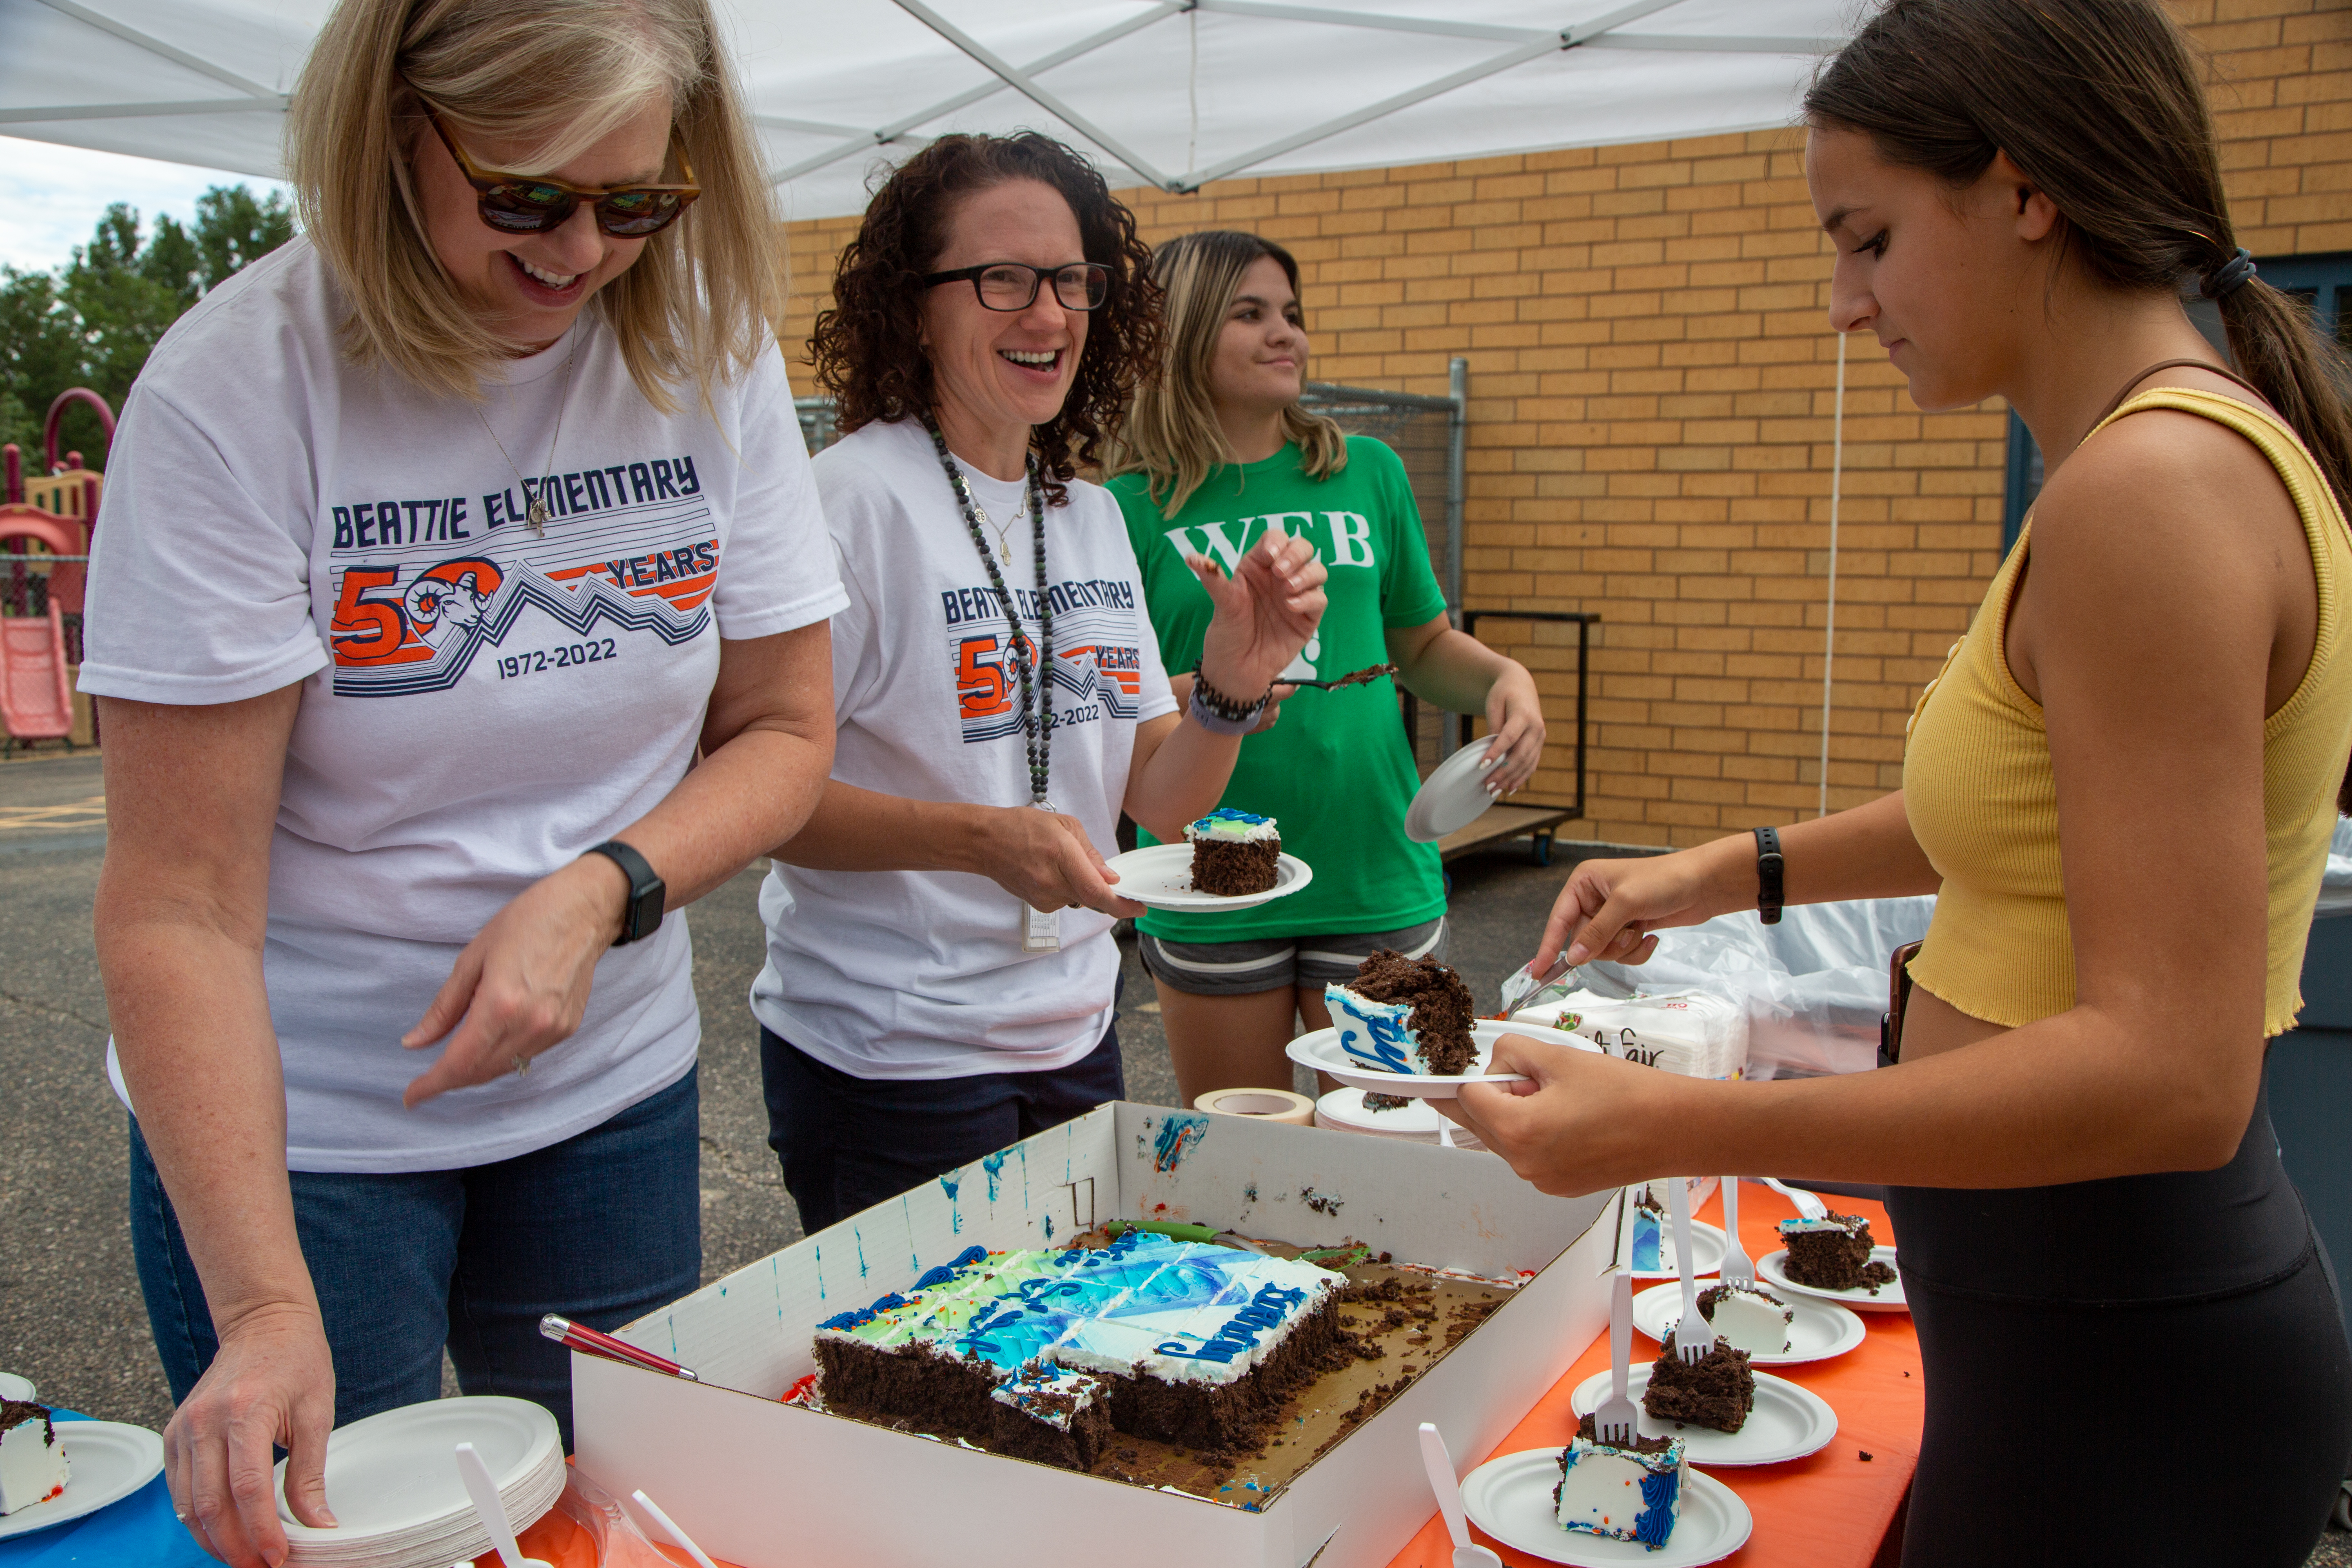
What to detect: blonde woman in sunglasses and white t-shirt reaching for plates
<box><xmin>82</xmin><ymin>0</ymin><xmax>844</xmax><ymax>1566</ymax></box>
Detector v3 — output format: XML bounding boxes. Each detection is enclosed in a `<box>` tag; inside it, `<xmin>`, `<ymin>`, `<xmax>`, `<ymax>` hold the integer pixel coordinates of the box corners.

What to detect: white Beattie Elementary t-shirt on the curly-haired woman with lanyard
<box><xmin>750</xmin><ymin>421</ymin><xmax>1176</xmax><ymax>1079</ymax></box>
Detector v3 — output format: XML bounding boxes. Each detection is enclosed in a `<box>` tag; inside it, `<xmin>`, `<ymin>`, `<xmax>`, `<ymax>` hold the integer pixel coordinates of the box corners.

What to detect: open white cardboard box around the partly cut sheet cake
<box><xmin>572</xmin><ymin>1100</ymin><xmax>1618</xmax><ymax>1568</ymax></box>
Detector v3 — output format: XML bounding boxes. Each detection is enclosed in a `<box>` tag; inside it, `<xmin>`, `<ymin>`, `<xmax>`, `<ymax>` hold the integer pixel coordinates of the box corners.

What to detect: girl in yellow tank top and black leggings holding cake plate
<box><xmin>1439</xmin><ymin>0</ymin><xmax>2352</xmax><ymax>1568</ymax></box>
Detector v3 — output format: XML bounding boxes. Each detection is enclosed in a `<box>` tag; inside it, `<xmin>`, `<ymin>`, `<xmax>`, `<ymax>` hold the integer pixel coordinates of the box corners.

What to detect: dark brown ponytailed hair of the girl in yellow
<box><xmin>1804</xmin><ymin>0</ymin><xmax>2352</xmax><ymax>813</ymax></box>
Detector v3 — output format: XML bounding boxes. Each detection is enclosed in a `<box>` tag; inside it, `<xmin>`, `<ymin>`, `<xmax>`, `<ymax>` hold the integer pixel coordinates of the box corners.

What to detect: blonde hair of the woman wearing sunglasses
<box><xmin>287</xmin><ymin>0</ymin><xmax>783</xmax><ymax>414</ymax></box>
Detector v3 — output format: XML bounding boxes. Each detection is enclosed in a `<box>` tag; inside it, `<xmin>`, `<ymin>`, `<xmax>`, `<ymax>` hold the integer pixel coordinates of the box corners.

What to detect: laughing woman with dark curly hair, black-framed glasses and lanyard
<box><xmin>750</xmin><ymin>131</ymin><xmax>1324</xmax><ymax>1232</ymax></box>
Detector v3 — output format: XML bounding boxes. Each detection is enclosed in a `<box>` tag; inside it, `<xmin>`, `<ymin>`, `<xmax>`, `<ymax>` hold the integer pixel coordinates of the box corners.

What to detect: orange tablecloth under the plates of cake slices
<box><xmin>1390</xmin><ymin>1187</ymin><xmax>1926</xmax><ymax>1568</ymax></box>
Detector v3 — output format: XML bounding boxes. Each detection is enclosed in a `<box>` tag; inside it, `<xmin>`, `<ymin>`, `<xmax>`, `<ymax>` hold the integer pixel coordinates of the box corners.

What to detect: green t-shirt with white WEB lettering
<box><xmin>1110</xmin><ymin>435</ymin><xmax>1446</xmax><ymax>943</ymax></box>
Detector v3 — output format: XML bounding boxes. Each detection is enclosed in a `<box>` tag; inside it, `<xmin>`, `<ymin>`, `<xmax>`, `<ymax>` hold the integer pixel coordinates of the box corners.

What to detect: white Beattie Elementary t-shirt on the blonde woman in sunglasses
<box><xmin>82</xmin><ymin>240</ymin><xmax>844</xmax><ymax>1171</ymax></box>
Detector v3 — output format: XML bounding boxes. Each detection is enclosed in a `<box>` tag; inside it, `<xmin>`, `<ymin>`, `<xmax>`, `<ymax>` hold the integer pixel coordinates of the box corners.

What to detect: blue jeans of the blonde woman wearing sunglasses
<box><xmin>132</xmin><ymin>1069</ymin><xmax>703</xmax><ymax>1453</ymax></box>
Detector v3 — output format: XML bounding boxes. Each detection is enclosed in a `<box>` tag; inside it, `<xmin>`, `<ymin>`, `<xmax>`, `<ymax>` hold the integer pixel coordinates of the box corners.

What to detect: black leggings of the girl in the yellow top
<box><xmin>1886</xmin><ymin>1081</ymin><xmax>2352</xmax><ymax>1568</ymax></box>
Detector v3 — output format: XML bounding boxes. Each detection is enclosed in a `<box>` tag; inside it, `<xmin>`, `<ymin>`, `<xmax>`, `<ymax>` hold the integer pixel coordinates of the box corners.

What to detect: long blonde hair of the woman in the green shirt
<box><xmin>1108</xmin><ymin>228</ymin><xmax>1348</xmax><ymax>517</ymax></box>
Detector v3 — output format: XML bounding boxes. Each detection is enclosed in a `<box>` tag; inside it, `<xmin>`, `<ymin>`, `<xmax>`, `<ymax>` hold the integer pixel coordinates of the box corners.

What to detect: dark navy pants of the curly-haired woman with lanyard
<box><xmin>760</xmin><ymin>1022</ymin><xmax>1127</xmax><ymax>1236</ymax></box>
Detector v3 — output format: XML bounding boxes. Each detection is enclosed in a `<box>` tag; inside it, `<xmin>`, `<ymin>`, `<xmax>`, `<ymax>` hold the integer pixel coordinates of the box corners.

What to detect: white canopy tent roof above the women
<box><xmin>0</xmin><ymin>0</ymin><xmax>1851</xmax><ymax>218</ymax></box>
